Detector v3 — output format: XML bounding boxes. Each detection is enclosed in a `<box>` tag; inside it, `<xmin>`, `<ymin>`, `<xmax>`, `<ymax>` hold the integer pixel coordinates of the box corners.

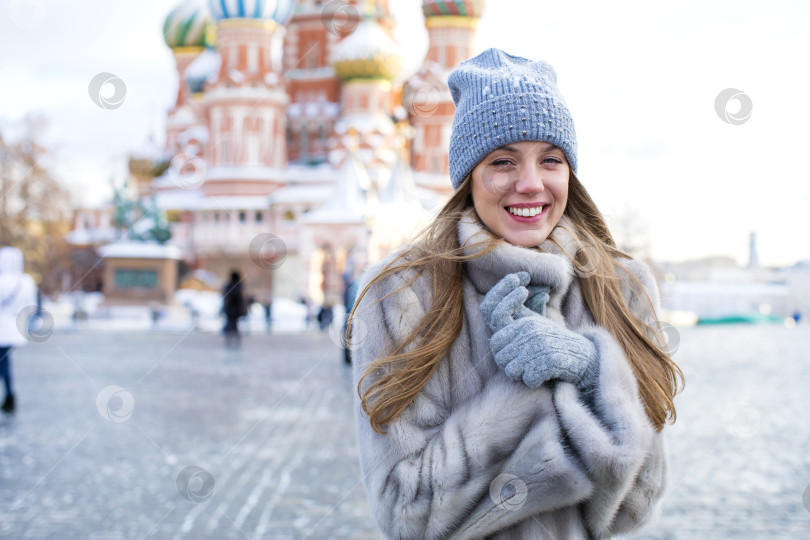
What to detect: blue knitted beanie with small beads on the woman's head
<box><xmin>448</xmin><ymin>49</ymin><xmax>577</xmax><ymax>189</ymax></box>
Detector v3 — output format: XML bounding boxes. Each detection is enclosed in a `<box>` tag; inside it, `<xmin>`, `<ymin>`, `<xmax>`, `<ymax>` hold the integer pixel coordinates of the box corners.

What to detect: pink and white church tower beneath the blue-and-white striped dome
<box><xmin>202</xmin><ymin>0</ymin><xmax>294</xmax><ymax>196</ymax></box>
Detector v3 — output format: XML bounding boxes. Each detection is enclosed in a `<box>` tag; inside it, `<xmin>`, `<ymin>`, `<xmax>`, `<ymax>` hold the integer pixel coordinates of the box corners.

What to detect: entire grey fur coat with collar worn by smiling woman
<box><xmin>353</xmin><ymin>213</ymin><xmax>666</xmax><ymax>540</ymax></box>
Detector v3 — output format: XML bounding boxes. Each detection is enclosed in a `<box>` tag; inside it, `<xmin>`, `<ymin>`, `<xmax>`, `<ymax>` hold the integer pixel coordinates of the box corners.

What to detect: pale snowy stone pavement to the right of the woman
<box><xmin>639</xmin><ymin>324</ymin><xmax>810</xmax><ymax>540</ymax></box>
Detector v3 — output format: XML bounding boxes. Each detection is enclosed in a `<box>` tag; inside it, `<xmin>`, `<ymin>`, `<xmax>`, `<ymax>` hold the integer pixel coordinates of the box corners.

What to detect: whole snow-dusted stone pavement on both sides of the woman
<box><xmin>0</xmin><ymin>325</ymin><xmax>810</xmax><ymax>540</ymax></box>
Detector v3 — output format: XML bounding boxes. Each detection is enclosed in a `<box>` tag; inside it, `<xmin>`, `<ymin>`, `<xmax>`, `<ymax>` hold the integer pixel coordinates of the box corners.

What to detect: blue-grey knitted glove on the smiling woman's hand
<box><xmin>480</xmin><ymin>272</ymin><xmax>599</xmax><ymax>390</ymax></box>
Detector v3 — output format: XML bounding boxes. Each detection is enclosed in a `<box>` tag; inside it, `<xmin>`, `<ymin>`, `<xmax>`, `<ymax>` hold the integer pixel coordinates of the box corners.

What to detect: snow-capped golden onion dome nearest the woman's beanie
<box><xmin>332</xmin><ymin>19</ymin><xmax>402</xmax><ymax>81</ymax></box>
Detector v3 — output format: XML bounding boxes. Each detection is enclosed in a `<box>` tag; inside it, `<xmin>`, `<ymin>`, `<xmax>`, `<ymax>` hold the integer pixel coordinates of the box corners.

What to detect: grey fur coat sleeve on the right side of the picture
<box><xmin>554</xmin><ymin>261</ymin><xmax>667</xmax><ymax>538</ymax></box>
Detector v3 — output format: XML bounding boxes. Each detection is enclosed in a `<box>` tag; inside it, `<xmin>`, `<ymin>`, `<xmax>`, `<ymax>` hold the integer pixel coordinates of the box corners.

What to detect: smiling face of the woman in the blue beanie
<box><xmin>472</xmin><ymin>141</ymin><xmax>570</xmax><ymax>247</ymax></box>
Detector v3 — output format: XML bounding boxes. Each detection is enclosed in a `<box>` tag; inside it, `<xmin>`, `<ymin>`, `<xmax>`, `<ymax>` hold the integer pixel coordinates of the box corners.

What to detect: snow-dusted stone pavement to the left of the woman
<box><xmin>0</xmin><ymin>333</ymin><xmax>379</xmax><ymax>539</ymax></box>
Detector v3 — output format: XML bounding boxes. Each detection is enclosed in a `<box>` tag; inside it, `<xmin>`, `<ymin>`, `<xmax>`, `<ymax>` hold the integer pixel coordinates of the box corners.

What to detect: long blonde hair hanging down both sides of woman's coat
<box><xmin>349</xmin><ymin>171</ymin><xmax>683</xmax><ymax>433</ymax></box>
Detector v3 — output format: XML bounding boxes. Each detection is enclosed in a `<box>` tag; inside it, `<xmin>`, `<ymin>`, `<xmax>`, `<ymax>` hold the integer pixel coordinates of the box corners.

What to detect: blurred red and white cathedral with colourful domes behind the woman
<box><xmin>69</xmin><ymin>0</ymin><xmax>484</xmax><ymax>305</ymax></box>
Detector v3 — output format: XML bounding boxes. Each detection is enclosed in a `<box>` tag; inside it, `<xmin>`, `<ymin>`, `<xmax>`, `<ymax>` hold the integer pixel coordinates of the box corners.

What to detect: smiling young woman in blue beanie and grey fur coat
<box><xmin>352</xmin><ymin>49</ymin><xmax>682</xmax><ymax>540</ymax></box>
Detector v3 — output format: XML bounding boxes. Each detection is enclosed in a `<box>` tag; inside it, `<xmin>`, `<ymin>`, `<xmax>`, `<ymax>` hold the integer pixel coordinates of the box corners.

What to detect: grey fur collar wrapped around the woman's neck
<box><xmin>458</xmin><ymin>208</ymin><xmax>577</xmax><ymax>309</ymax></box>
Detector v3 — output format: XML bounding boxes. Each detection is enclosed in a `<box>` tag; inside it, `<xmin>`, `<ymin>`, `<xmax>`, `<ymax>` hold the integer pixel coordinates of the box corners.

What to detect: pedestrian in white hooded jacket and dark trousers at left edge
<box><xmin>0</xmin><ymin>247</ymin><xmax>39</xmax><ymax>413</ymax></box>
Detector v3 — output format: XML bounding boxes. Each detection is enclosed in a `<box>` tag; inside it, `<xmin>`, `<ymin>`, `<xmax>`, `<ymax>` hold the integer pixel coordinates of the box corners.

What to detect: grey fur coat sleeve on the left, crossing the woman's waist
<box><xmin>353</xmin><ymin>260</ymin><xmax>593</xmax><ymax>539</ymax></box>
